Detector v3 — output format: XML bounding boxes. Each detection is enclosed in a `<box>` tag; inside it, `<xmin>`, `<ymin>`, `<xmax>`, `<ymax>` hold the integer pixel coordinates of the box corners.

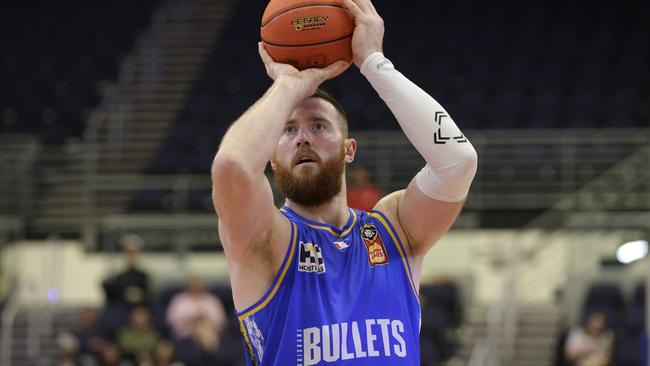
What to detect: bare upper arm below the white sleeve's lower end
<box><xmin>397</xmin><ymin>179</ymin><xmax>465</xmax><ymax>255</ymax></box>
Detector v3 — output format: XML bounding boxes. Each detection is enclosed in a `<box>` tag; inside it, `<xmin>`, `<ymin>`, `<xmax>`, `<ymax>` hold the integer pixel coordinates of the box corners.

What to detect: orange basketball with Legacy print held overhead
<box><xmin>261</xmin><ymin>0</ymin><xmax>354</xmax><ymax>70</ymax></box>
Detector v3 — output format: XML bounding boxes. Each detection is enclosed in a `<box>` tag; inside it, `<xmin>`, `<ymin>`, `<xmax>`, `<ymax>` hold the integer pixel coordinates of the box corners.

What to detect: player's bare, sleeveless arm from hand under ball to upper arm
<box><xmin>212</xmin><ymin>45</ymin><xmax>349</xmax><ymax>258</ymax></box>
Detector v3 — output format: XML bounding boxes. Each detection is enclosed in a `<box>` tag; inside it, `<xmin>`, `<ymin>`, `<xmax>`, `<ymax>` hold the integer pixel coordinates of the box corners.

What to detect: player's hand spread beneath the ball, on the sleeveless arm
<box><xmin>258</xmin><ymin>42</ymin><xmax>351</xmax><ymax>99</ymax></box>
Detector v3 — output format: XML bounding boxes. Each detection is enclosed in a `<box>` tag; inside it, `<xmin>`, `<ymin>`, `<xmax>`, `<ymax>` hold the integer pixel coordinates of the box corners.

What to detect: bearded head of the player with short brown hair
<box><xmin>271</xmin><ymin>90</ymin><xmax>357</xmax><ymax>206</ymax></box>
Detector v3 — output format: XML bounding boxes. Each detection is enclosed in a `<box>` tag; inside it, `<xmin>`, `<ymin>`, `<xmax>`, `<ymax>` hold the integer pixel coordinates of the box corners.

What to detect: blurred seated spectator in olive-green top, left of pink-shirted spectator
<box><xmin>117</xmin><ymin>306</ymin><xmax>161</xmax><ymax>365</ymax></box>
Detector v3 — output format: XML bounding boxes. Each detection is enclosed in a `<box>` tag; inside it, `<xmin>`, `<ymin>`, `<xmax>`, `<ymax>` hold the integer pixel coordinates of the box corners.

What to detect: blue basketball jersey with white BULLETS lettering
<box><xmin>237</xmin><ymin>206</ymin><xmax>420</xmax><ymax>366</ymax></box>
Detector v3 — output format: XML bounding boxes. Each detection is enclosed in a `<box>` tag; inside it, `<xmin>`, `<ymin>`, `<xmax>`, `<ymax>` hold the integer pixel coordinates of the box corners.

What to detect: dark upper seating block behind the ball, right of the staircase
<box><xmin>151</xmin><ymin>0</ymin><xmax>650</xmax><ymax>173</ymax></box>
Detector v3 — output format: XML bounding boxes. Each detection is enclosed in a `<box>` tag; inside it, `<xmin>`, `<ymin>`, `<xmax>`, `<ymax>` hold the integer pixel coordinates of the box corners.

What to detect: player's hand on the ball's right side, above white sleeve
<box><xmin>343</xmin><ymin>0</ymin><xmax>384</xmax><ymax>68</ymax></box>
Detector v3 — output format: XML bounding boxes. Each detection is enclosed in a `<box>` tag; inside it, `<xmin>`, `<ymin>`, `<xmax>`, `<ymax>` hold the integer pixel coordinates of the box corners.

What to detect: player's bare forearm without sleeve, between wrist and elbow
<box><xmin>213</xmin><ymin>78</ymin><xmax>300</xmax><ymax>174</ymax></box>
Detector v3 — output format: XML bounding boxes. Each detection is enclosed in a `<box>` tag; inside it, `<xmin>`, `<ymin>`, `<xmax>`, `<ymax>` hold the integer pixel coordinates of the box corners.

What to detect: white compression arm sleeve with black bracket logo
<box><xmin>361</xmin><ymin>52</ymin><xmax>478</xmax><ymax>202</ymax></box>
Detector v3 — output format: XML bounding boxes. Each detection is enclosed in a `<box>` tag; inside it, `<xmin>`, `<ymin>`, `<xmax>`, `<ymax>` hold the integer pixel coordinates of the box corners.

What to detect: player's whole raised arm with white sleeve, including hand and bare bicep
<box><xmin>345</xmin><ymin>0</ymin><xmax>477</xmax><ymax>255</ymax></box>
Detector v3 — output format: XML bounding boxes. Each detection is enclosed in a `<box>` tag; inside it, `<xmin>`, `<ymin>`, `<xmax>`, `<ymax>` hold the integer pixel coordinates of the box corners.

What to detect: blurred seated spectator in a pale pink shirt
<box><xmin>167</xmin><ymin>277</ymin><xmax>227</xmax><ymax>351</ymax></box>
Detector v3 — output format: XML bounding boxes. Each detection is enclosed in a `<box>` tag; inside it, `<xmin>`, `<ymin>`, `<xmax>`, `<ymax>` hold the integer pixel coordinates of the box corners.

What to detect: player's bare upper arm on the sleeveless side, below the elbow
<box><xmin>212</xmin><ymin>159</ymin><xmax>278</xmax><ymax>255</ymax></box>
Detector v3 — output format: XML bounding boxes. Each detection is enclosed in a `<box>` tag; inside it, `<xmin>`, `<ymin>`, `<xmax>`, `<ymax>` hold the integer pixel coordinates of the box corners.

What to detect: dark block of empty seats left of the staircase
<box><xmin>0</xmin><ymin>0</ymin><xmax>158</xmax><ymax>144</ymax></box>
